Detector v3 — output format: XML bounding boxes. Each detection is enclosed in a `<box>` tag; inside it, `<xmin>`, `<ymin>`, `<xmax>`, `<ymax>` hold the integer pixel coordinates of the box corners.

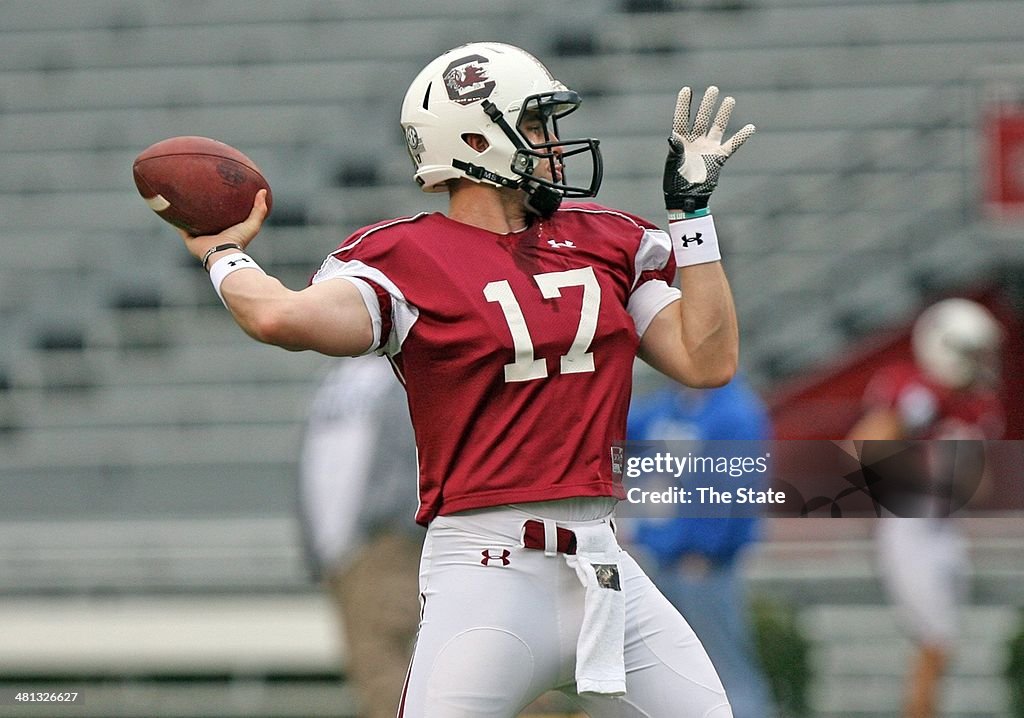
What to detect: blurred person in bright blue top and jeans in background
<box><xmin>629</xmin><ymin>374</ymin><xmax>775</xmax><ymax>718</ymax></box>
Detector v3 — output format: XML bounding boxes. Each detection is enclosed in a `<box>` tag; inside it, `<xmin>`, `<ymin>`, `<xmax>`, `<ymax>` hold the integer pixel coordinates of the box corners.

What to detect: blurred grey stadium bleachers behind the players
<box><xmin>0</xmin><ymin>0</ymin><xmax>1024</xmax><ymax>718</ymax></box>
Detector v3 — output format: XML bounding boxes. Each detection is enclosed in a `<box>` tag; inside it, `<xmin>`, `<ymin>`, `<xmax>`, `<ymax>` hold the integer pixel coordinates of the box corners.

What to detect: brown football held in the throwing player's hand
<box><xmin>132</xmin><ymin>136</ymin><xmax>271</xmax><ymax>237</ymax></box>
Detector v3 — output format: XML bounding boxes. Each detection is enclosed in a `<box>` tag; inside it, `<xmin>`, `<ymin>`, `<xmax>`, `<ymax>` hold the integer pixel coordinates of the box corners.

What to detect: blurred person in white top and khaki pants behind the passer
<box><xmin>299</xmin><ymin>356</ymin><xmax>423</xmax><ymax>718</ymax></box>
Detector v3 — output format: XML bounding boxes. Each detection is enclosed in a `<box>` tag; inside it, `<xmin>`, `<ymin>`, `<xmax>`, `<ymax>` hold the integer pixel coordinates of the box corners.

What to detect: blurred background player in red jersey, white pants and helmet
<box><xmin>850</xmin><ymin>298</ymin><xmax>1005</xmax><ymax>718</ymax></box>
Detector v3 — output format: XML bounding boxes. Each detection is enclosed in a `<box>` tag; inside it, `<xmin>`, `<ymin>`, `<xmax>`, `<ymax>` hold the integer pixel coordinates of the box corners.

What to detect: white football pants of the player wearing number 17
<box><xmin>399</xmin><ymin>507</ymin><xmax>732</xmax><ymax>718</ymax></box>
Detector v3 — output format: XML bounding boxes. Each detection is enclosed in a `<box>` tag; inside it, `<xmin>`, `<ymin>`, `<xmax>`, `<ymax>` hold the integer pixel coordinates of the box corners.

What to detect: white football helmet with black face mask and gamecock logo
<box><xmin>401</xmin><ymin>42</ymin><xmax>602</xmax><ymax>216</ymax></box>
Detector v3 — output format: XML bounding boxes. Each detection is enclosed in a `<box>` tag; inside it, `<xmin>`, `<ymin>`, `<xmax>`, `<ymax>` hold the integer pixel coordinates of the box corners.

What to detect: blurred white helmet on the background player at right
<box><xmin>911</xmin><ymin>298</ymin><xmax>1002</xmax><ymax>388</ymax></box>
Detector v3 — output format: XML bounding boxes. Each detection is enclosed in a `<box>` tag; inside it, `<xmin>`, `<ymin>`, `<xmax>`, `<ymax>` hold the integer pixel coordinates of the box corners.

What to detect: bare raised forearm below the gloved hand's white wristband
<box><xmin>640</xmin><ymin>262</ymin><xmax>739</xmax><ymax>387</ymax></box>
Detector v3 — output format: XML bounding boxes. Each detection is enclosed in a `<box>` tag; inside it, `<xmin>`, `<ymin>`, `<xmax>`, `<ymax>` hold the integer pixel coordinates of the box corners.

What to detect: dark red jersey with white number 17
<box><xmin>312</xmin><ymin>200</ymin><xmax>680</xmax><ymax>523</ymax></box>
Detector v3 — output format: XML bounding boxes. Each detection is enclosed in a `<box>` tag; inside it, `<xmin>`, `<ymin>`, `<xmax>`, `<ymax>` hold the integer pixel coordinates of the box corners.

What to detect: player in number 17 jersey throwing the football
<box><xmin>176</xmin><ymin>42</ymin><xmax>754</xmax><ymax>718</ymax></box>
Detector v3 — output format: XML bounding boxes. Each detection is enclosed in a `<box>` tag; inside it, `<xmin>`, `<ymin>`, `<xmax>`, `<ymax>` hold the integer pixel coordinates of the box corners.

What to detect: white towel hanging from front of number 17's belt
<box><xmin>565</xmin><ymin>523</ymin><xmax>626</xmax><ymax>695</ymax></box>
